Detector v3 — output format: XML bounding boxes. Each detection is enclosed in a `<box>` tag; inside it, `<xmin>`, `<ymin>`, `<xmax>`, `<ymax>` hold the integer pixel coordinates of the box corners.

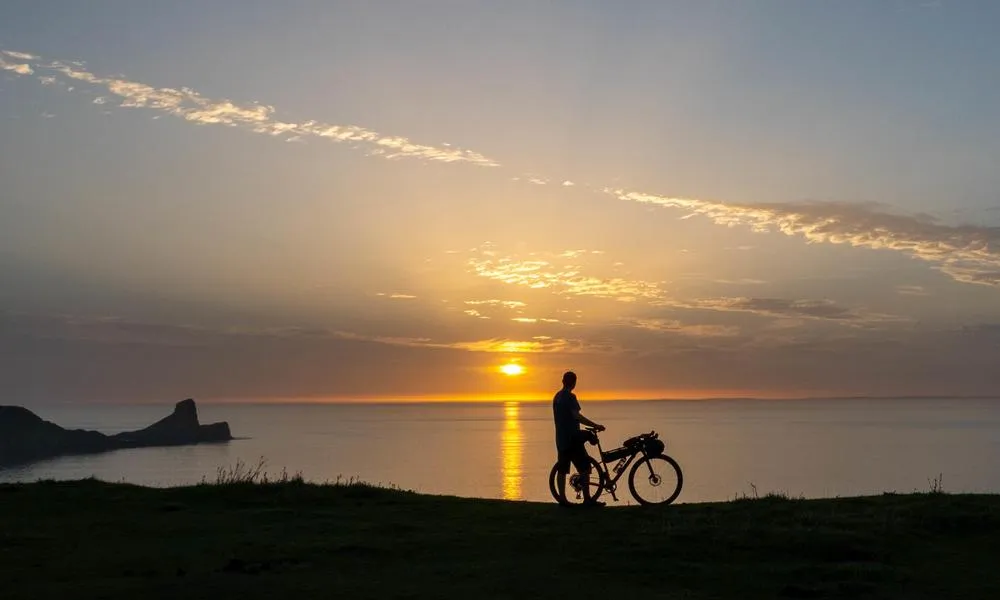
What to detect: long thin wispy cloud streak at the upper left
<box><xmin>0</xmin><ymin>50</ymin><xmax>499</xmax><ymax>167</ymax></box>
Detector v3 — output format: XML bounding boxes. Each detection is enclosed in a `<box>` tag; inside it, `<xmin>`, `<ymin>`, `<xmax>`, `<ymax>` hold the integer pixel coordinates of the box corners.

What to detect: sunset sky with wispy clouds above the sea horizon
<box><xmin>0</xmin><ymin>0</ymin><xmax>1000</xmax><ymax>405</ymax></box>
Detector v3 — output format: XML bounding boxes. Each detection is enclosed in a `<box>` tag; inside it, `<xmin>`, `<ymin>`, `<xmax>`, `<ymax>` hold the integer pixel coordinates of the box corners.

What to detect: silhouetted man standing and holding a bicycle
<box><xmin>552</xmin><ymin>371</ymin><xmax>604</xmax><ymax>504</ymax></box>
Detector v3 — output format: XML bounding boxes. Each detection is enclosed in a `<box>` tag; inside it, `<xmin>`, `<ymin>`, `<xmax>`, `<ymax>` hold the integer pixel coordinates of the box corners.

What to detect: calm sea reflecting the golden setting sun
<box><xmin>0</xmin><ymin>399</ymin><xmax>1000</xmax><ymax>502</ymax></box>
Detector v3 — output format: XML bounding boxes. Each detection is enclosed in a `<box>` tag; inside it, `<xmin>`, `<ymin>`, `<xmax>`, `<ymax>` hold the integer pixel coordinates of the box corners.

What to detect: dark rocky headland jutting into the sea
<box><xmin>0</xmin><ymin>399</ymin><xmax>233</xmax><ymax>466</ymax></box>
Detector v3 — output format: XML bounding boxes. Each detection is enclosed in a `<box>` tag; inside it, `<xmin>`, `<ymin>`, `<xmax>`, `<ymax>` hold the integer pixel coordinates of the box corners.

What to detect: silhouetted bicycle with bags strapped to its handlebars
<box><xmin>549</xmin><ymin>427</ymin><xmax>684</xmax><ymax>506</ymax></box>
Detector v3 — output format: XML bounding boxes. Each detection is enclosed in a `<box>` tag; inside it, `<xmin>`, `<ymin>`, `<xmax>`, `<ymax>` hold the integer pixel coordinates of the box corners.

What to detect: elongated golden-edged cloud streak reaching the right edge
<box><xmin>605</xmin><ymin>189</ymin><xmax>1000</xmax><ymax>286</ymax></box>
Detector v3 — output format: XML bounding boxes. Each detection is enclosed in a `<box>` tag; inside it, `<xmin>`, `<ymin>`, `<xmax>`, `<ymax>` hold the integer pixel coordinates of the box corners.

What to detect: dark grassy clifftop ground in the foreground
<box><xmin>0</xmin><ymin>481</ymin><xmax>1000</xmax><ymax>600</ymax></box>
